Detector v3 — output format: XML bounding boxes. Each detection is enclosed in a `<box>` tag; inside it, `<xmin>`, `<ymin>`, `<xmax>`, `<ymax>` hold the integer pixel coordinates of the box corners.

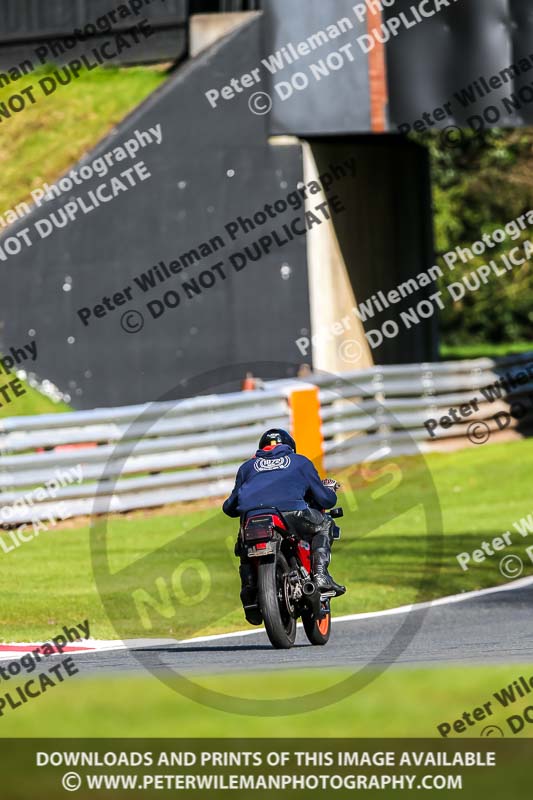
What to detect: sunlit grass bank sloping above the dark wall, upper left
<box><xmin>0</xmin><ymin>67</ymin><xmax>165</xmax><ymax>220</ymax></box>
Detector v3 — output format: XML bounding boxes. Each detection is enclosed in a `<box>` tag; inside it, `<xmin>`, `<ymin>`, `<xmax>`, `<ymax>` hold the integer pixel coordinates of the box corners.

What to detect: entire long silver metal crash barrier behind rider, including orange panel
<box><xmin>0</xmin><ymin>352</ymin><xmax>533</xmax><ymax>525</ymax></box>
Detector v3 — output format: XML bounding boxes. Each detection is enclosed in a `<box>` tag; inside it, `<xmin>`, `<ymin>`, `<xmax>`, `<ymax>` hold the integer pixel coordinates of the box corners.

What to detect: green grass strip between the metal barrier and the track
<box><xmin>0</xmin><ymin>440</ymin><xmax>533</xmax><ymax>641</ymax></box>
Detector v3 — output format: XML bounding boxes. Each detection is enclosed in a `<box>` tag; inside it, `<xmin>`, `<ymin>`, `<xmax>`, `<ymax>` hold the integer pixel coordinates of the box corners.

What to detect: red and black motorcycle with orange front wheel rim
<box><xmin>238</xmin><ymin>500</ymin><xmax>343</xmax><ymax>649</ymax></box>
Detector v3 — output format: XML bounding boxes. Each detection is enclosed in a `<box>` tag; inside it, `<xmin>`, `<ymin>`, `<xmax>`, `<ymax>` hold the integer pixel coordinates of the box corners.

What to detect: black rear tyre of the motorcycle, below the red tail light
<box><xmin>257</xmin><ymin>553</ymin><xmax>296</xmax><ymax>650</ymax></box>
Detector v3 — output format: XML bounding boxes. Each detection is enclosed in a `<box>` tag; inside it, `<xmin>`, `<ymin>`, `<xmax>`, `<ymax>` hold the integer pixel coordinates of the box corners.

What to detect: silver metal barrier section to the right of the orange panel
<box><xmin>313</xmin><ymin>352</ymin><xmax>533</xmax><ymax>470</ymax></box>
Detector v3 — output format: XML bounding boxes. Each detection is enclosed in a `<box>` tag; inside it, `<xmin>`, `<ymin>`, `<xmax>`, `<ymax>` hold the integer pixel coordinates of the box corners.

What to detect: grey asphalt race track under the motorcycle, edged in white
<box><xmin>71</xmin><ymin>578</ymin><xmax>533</xmax><ymax>676</ymax></box>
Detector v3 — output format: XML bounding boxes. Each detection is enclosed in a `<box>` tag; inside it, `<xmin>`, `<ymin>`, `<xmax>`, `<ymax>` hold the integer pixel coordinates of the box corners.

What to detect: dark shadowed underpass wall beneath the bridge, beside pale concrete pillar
<box><xmin>311</xmin><ymin>135</ymin><xmax>438</xmax><ymax>364</ymax></box>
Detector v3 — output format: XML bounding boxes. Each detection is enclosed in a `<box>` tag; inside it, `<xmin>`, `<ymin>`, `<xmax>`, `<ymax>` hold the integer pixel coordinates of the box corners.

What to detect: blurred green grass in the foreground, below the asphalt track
<box><xmin>0</xmin><ymin>665</ymin><xmax>533</xmax><ymax>739</ymax></box>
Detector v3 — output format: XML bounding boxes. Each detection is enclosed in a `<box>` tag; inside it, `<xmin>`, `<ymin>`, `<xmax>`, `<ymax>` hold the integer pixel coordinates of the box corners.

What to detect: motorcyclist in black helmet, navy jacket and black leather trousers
<box><xmin>222</xmin><ymin>428</ymin><xmax>346</xmax><ymax>625</ymax></box>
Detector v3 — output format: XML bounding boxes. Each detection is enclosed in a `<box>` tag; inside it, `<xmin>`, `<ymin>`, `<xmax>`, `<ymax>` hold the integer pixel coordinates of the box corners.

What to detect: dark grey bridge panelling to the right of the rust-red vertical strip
<box><xmin>385</xmin><ymin>0</ymin><xmax>533</xmax><ymax>129</ymax></box>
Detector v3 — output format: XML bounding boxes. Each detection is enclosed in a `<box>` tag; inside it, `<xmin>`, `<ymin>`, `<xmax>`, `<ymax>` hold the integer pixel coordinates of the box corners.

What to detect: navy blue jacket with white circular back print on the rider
<box><xmin>222</xmin><ymin>444</ymin><xmax>337</xmax><ymax>517</ymax></box>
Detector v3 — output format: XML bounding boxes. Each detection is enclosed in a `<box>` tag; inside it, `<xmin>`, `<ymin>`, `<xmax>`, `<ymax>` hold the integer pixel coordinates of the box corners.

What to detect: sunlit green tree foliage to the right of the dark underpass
<box><xmin>416</xmin><ymin>128</ymin><xmax>533</xmax><ymax>345</ymax></box>
